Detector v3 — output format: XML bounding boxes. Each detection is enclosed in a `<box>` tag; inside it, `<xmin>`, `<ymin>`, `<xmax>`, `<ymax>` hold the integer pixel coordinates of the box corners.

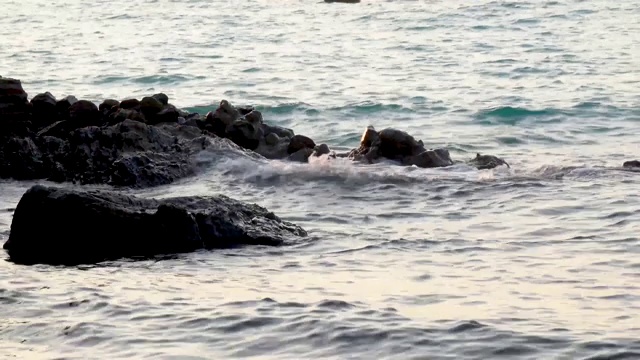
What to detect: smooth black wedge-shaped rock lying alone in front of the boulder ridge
<box><xmin>4</xmin><ymin>185</ymin><xmax>307</xmax><ymax>265</ymax></box>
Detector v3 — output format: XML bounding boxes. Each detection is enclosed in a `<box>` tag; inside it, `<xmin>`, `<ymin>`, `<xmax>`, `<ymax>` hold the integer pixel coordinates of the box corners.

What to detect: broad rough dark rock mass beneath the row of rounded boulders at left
<box><xmin>0</xmin><ymin>120</ymin><xmax>215</xmax><ymax>187</ymax></box>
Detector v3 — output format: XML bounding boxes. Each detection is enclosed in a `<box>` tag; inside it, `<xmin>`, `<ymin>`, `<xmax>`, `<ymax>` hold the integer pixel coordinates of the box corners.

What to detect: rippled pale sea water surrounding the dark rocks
<box><xmin>0</xmin><ymin>0</ymin><xmax>640</xmax><ymax>359</ymax></box>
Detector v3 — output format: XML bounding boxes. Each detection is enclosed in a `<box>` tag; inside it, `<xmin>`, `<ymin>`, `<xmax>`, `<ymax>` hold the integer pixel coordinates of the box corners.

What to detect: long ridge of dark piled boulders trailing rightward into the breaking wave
<box><xmin>0</xmin><ymin>78</ymin><xmax>508</xmax><ymax>187</ymax></box>
